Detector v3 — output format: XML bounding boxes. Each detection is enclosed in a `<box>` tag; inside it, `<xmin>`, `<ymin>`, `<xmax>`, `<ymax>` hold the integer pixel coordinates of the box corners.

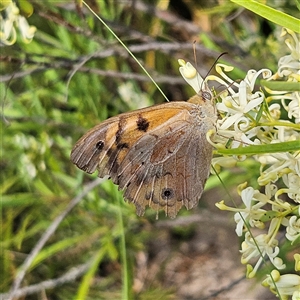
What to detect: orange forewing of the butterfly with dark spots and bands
<box><xmin>71</xmin><ymin>102</ymin><xmax>184</xmax><ymax>173</ymax></box>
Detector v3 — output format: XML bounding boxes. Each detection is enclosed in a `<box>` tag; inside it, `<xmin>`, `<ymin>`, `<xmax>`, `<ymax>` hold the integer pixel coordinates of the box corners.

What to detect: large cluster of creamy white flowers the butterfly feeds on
<box><xmin>179</xmin><ymin>29</ymin><xmax>300</xmax><ymax>300</ymax></box>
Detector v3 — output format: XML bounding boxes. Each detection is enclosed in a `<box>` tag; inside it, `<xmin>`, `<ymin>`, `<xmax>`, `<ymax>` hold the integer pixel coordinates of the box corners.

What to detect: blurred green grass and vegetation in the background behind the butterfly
<box><xmin>0</xmin><ymin>0</ymin><xmax>296</xmax><ymax>299</ymax></box>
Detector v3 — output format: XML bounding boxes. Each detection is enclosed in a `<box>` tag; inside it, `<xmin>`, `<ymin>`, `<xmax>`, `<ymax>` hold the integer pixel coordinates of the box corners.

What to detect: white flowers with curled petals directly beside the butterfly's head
<box><xmin>209</xmin><ymin>64</ymin><xmax>278</xmax><ymax>148</ymax></box>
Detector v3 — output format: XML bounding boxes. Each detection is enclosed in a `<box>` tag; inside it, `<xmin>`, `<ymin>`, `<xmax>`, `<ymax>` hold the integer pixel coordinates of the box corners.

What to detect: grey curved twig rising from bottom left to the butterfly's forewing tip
<box><xmin>8</xmin><ymin>178</ymin><xmax>103</xmax><ymax>300</ymax></box>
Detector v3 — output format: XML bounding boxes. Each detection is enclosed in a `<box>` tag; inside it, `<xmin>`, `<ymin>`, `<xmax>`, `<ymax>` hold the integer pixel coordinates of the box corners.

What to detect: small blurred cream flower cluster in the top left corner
<box><xmin>0</xmin><ymin>1</ymin><xmax>36</xmax><ymax>46</ymax></box>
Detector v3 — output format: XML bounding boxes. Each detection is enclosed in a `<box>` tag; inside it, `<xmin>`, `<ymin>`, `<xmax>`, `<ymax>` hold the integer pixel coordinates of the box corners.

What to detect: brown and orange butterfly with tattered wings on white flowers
<box><xmin>71</xmin><ymin>79</ymin><xmax>217</xmax><ymax>218</ymax></box>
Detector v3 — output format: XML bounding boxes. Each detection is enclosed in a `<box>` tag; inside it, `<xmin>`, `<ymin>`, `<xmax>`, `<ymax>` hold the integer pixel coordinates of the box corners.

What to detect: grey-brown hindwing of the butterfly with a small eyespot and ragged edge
<box><xmin>112</xmin><ymin>110</ymin><xmax>193</xmax><ymax>217</ymax></box>
